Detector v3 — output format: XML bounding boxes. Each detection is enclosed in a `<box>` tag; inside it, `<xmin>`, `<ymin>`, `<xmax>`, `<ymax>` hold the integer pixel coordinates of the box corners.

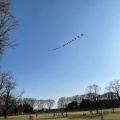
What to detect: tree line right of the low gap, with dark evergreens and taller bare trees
<box><xmin>58</xmin><ymin>80</ymin><xmax>120</xmax><ymax>114</ymax></box>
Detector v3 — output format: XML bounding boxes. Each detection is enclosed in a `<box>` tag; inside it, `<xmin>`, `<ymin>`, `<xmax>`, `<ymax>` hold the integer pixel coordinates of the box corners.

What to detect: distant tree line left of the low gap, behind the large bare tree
<box><xmin>0</xmin><ymin>95</ymin><xmax>55</xmax><ymax>116</ymax></box>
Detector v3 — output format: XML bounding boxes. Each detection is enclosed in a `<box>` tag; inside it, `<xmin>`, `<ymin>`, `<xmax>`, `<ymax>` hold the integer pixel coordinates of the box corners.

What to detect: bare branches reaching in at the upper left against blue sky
<box><xmin>0</xmin><ymin>0</ymin><xmax>18</xmax><ymax>56</ymax></box>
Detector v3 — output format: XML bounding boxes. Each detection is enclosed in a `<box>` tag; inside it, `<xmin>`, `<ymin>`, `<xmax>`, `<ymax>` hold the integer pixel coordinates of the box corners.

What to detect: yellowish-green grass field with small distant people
<box><xmin>0</xmin><ymin>109</ymin><xmax>120</xmax><ymax>120</ymax></box>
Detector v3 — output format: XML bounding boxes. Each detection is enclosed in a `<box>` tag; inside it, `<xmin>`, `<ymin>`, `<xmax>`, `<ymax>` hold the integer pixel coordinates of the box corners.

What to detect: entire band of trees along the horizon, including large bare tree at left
<box><xmin>0</xmin><ymin>79</ymin><xmax>120</xmax><ymax>116</ymax></box>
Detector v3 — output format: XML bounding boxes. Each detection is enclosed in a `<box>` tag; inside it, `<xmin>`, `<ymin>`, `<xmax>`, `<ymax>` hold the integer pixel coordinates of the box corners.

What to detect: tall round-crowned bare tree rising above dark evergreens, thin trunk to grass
<box><xmin>86</xmin><ymin>84</ymin><xmax>101</xmax><ymax>114</ymax></box>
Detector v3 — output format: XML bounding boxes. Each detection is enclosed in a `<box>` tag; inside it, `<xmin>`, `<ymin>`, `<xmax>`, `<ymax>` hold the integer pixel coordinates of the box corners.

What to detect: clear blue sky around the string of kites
<box><xmin>2</xmin><ymin>0</ymin><xmax>120</xmax><ymax>101</ymax></box>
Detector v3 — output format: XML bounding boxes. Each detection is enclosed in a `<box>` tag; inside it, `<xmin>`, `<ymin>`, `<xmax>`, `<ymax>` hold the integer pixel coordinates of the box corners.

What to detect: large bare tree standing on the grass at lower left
<box><xmin>0</xmin><ymin>73</ymin><xmax>24</xmax><ymax>118</ymax></box>
